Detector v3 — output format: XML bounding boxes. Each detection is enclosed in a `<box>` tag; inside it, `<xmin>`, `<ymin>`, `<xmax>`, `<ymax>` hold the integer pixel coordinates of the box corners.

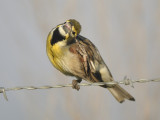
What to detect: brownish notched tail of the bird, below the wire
<box><xmin>108</xmin><ymin>85</ymin><xmax>135</xmax><ymax>103</ymax></box>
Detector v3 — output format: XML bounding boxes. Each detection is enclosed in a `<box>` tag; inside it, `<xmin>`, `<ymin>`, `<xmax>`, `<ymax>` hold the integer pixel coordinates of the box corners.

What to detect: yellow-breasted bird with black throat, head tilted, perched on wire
<box><xmin>47</xmin><ymin>19</ymin><xmax>135</xmax><ymax>103</ymax></box>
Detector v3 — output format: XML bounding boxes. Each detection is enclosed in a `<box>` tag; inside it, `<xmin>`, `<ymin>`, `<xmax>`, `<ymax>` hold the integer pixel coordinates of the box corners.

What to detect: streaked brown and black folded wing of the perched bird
<box><xmin>69</xmin><ymin>35</ymin><xmax>112</xmax><ymax>82</ymax></box>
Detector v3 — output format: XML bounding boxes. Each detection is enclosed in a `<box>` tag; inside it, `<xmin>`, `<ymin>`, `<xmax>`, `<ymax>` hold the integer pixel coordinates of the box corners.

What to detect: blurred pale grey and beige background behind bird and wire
<box><xmin>0</xmin><ymin>0</ymin><xmax>160</xmax><ymax>120</ymax></box>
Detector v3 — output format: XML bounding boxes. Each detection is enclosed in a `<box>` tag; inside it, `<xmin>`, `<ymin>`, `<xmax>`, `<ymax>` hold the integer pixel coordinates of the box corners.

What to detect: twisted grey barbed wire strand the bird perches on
<box><xmin>0</xmin><ymin>76</ymin><xmax>160</xmax><ymax>101</ymax></box>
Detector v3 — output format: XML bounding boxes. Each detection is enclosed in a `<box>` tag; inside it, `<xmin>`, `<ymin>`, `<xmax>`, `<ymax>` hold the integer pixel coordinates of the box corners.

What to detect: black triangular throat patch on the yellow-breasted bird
<box><xmin>51</xmin><ymin>28</ymin><xmax>65</xmax><ymax>45</ymax></box>
